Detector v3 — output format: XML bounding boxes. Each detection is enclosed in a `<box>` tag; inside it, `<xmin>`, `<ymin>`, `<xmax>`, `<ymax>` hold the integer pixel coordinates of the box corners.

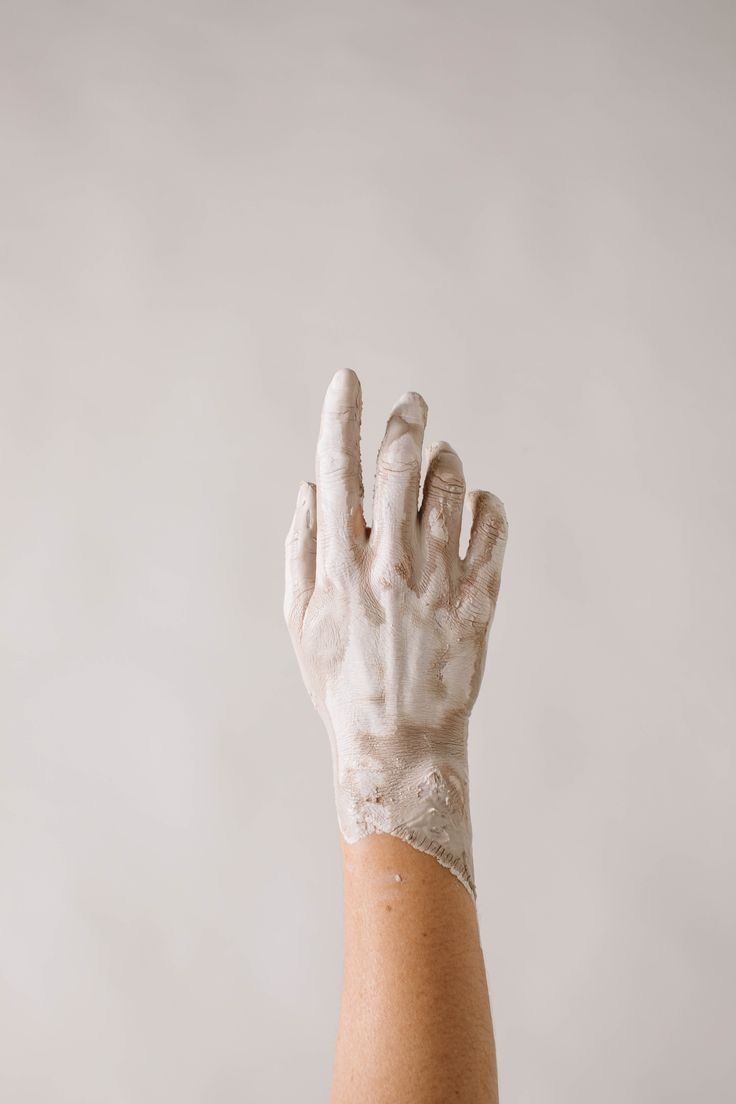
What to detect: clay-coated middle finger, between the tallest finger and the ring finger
<box><xmin>371</xmin><ymin>391</ymin><xmax>427</xmax><ymax>561</ymax></box>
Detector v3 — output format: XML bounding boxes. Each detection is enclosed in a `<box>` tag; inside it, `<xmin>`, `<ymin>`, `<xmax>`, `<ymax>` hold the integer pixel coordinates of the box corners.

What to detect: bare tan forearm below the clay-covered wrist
<box><xmin>332</xmin><ymin>835</ymin><xmax>498</xmax><ymax>1104</ymax></box>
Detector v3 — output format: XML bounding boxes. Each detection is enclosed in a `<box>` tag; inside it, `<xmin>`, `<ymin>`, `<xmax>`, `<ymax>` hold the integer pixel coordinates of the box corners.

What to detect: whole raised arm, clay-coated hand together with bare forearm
<box><xmin>284</xmin><ymin>370</ymin><xmax>506</xmax><ymax>1104</ymax></box>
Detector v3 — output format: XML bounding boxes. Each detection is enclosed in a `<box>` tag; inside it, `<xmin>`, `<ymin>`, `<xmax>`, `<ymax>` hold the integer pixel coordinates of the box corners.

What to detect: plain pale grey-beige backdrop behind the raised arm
<box><xmin>0</xmin><ymin>0</ymin><xmax>736</xmax><ymax>1104</ymax></box>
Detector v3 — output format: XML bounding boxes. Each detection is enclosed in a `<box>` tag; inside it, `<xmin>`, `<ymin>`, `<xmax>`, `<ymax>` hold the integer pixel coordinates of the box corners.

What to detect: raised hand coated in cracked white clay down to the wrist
<box><xmin>285</xmin><ymin>370</ymin><xmax>506</xmax><ymax>893</ymax></box>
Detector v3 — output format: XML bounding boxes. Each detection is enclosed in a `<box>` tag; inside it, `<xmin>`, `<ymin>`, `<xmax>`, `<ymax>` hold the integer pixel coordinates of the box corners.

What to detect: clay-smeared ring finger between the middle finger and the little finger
<box><xmin>420</xmin><ymin>440</ymin><xmax>466</xmax><ymax>563</ymax></box>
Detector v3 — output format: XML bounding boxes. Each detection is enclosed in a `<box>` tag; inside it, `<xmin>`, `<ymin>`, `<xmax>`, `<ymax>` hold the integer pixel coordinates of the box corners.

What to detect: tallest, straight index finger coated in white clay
<box><xmin>317</xmin><ymin>368</ymin><xmax>365</xmax><ymax>572</ymax></box>
